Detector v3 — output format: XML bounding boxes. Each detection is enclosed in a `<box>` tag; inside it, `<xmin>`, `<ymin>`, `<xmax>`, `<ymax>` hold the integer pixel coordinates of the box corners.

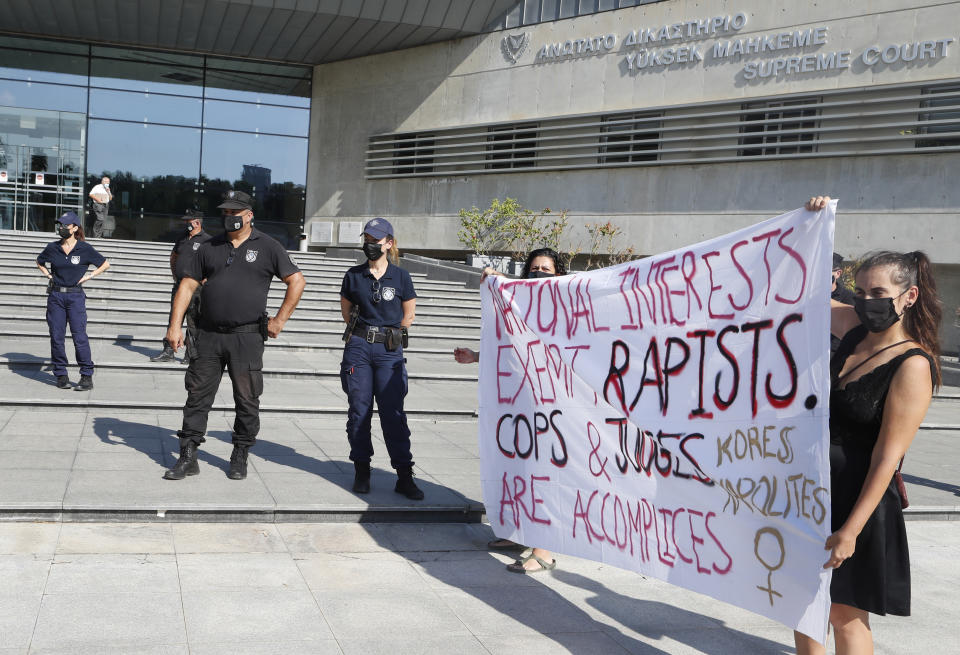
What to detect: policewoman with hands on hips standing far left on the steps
<box><xmin>37</xmin><ymin>212</ymin><xmax>110</xmax><ymax>391</ymax></box>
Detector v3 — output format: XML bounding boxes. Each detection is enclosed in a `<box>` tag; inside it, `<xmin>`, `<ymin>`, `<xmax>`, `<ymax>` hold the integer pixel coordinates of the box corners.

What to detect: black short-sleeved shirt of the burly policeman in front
<box><xmin>184</xmin><ymin>228</ymin><xmax>300</xmax><ymax>328</ymax></box>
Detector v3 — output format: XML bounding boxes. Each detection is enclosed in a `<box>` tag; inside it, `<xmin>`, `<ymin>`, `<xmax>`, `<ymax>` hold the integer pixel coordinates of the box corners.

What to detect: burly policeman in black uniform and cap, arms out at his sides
<box><xmin>163</xmin><ymin>191</ymin><xmax>306</xmax><ymax>480</ymax></box>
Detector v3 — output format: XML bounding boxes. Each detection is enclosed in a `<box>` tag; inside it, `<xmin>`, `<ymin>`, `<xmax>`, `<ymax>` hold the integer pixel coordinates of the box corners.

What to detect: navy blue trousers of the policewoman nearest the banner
<box><xmin>340</xmin><ymin>335</ymin><xmax>413</xmax><ymax>468</ymax></box>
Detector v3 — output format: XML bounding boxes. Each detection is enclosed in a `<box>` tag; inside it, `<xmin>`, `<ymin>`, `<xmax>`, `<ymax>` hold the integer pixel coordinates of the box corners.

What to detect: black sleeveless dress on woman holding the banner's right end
<box><xmin>830</xmin><ymin>326</ymin><xmax>934</xmax><ymax>616</ymax></box>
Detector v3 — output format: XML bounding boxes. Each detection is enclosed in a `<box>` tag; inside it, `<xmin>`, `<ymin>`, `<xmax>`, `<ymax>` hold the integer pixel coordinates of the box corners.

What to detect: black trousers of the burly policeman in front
<box><xmin>177</xmin><ymin>329</ymin><xmax>263</xmax><ymax>446</ymax></box>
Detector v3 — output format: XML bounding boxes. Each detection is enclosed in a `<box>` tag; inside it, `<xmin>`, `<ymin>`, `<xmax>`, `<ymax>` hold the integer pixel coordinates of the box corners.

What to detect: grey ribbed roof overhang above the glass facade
<box><xmin>0</xmin><ymin>0</ymin><xmax>517</xmax><ymax>64</ymax></box>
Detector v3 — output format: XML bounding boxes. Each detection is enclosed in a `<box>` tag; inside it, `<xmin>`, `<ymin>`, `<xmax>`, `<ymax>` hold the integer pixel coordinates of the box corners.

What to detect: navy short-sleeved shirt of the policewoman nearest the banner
<box><xmin>340</xmin><ymin>264</ymin><xmax>417</xmax><ymax>327</ymax></box>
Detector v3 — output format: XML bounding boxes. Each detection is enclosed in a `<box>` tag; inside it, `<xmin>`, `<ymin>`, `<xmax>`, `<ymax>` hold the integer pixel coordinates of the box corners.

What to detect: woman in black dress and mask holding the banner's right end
<box><xmin>795</xmin><ymin>197</ymin><xmax>941</xmax><ymax>655</ymax></box>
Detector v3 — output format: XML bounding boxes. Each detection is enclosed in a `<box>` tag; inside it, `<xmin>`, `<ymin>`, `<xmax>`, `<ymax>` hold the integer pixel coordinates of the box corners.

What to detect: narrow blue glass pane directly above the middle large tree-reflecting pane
<box><xmin>90</xmin><ymin>89</ymin><xmax>203</xmax><ymax>127</ymax></box>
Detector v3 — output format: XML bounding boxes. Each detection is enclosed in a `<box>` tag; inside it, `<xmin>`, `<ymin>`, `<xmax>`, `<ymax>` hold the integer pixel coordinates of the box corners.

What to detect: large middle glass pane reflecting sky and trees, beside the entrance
<box><xmin>87</xmin><ymin>119</ymin><xmax>200</xmax><ymax>239</ymax></box>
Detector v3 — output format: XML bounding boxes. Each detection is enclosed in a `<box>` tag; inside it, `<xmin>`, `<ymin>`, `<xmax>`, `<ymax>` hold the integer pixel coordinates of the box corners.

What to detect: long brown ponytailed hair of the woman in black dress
<box><xmin>857</xmin><ymin>250</ymin><xmax>943</xmax><ymax>388</ymax></box>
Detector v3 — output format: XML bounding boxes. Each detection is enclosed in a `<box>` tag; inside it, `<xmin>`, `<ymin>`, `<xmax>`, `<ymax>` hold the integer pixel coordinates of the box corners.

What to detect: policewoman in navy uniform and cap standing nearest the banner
<box><xmin>340</xmin><ymin>218</ymin><xmax>423</xmax><ymax>500</ymax></box>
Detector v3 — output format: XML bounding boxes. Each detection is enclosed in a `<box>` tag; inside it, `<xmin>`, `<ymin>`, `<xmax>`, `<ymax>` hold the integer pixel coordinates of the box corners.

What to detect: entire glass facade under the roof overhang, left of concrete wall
<box><xmin>0</xmin><ymin>36</ymin><xmax>312</xmax><ymax>248</ymax></box>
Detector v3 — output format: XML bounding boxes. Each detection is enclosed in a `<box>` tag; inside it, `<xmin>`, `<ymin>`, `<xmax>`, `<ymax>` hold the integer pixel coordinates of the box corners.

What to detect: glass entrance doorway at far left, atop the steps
<box><xmin>0</xmin><ymin>107</ymin><xmax>86</xmax><ymax>232</ymax></box>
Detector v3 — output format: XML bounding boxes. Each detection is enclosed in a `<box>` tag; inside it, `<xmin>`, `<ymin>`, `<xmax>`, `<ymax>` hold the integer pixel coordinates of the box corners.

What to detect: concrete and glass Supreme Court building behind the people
<box><xmin>0</xmin><ymin>0</ymin><xmax>960</xmax><ymax>351</ymax></box>
